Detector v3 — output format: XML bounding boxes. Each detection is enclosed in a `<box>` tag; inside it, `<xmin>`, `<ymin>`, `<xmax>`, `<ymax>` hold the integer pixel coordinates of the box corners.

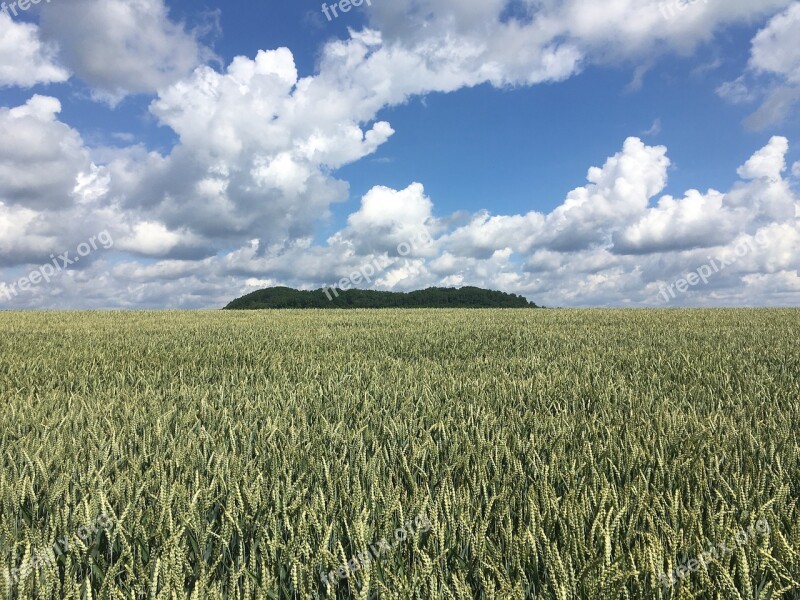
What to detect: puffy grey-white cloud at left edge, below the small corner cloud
<box><xmin>0</xmin><ymin>95</ymin><xmax>123</xmax><ymax>267</ymax></box>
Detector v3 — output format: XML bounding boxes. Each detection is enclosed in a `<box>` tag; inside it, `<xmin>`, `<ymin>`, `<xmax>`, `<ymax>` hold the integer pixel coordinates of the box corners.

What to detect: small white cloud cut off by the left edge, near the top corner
<box><xmin>0</xmin><ymin>12</ymin><xmax>69</xmax><ymax>88</ymax></box>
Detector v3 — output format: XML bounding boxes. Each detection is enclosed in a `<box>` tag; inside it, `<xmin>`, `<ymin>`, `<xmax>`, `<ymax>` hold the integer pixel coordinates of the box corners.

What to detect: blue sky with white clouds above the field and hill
<box><xmin>0</xmin><ymin>0</ymin><xmax>800</xmax><ymax>310</ymax></box>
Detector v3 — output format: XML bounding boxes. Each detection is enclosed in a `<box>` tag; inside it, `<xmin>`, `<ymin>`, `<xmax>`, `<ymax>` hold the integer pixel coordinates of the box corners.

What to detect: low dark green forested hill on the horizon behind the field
<box><xmin>225</xmin><ymin>287</ymin><xmax>539</xmax><ymax>310</ymax></box>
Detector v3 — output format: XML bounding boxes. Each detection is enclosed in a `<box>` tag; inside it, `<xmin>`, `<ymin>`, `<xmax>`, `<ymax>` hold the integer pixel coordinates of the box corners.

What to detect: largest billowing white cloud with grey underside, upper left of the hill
<box><xmin>110</xmin><ymin>48</ymin><xmax>393</xmax><ymax>251</ymax></box>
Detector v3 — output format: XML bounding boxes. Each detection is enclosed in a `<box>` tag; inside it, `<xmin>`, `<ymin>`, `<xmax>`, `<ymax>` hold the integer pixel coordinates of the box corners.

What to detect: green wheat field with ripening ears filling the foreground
<box><xmin>0</xmin><ymin>310</ymin><xmax>800</xmax><ymax>600</ymax></box>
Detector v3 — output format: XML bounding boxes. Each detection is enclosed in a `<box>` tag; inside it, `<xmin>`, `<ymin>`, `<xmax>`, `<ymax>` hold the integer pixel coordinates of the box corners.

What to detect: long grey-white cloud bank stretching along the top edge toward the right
<box><xmin>368</xmin><ymin>0</ymin><xmax>791</xmax><ymax>86</ymax></box>
